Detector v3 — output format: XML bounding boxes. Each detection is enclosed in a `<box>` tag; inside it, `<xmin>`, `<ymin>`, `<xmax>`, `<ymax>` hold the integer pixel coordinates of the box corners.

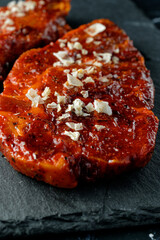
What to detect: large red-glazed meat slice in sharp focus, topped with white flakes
<box><xmin>0</xmin><ymin>19</ymin><xmax>158</xmax><ymax>188</ymax></box>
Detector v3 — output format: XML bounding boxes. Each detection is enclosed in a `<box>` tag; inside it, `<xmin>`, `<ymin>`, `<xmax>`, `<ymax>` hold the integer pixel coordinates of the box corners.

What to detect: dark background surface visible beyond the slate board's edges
<box><xmin>0</xmin><ymin>0</ymin><xmax>160</xmax><ymax>240</ymax></box>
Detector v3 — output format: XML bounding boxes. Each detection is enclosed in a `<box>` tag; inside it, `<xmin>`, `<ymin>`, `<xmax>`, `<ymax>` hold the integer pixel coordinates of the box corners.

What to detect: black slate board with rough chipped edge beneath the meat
<box><xmin>0</xmin><ymin>0</ymin><xmax>160</xmax><ymax>237</ymax></box>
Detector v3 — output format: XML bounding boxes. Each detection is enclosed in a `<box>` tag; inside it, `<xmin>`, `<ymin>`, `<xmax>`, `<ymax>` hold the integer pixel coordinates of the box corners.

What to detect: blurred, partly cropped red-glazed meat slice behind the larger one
<box><xmin>0</xmin><ymin>0</ymin><xmax>70</xmax><ymax>80</ymax></box>
